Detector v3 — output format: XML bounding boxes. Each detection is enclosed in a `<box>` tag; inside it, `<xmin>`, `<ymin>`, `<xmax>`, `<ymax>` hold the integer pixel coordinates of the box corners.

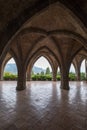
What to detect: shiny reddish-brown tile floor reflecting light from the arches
<box><xmin>0</xmin><ymin>81</ymin><xmax>87</xmax><ymax>130</ymax></box>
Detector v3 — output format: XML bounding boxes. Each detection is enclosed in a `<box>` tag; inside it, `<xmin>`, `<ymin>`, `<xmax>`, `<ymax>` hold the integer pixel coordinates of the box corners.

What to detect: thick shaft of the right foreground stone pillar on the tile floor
<box><xmin>61</xmin><ymin>66</ymin><xmax>69</xmax><ymax>90</ymax></box>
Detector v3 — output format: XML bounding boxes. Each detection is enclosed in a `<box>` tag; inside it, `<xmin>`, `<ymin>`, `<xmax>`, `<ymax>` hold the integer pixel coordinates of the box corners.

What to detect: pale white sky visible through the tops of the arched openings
<box><xmin>8</xmin><ymin>56</ymin><xmax>85</xmax><ymax>72</ymax></box>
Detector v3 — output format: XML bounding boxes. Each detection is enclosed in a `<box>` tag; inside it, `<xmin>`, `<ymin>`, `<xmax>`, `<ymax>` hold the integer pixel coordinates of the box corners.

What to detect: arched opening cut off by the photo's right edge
<box><xmin>80</xmin><ymin>59</ymin><xmax>87</xmax><ymax>80</ymax></box>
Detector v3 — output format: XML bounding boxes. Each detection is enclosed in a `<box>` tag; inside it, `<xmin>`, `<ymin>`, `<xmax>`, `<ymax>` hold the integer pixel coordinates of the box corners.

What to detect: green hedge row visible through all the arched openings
<box><xmin>3</xmin><ymin>72</ymin><xmax>86</xmax><ymax>81</ymax></box>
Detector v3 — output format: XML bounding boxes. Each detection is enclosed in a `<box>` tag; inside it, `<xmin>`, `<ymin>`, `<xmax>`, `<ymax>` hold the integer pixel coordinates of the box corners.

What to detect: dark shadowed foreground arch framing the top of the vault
<box><xmin>0</xmin><ymin>0</ymin><xmax>87</xmax><ymax>60</ymax></box>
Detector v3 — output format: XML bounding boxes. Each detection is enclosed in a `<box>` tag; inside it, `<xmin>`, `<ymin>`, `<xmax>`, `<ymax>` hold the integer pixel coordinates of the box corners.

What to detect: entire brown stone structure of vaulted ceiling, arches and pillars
<box><xmin>0</xmin><ymin>0</ymin><xmax>87</xmax><ymax>90</ymax></box>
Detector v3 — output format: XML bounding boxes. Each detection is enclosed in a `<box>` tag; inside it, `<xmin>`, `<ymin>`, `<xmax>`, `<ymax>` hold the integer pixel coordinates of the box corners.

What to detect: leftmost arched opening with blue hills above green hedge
<box><xmin>3</xmin><ymin>58</ymin><xmax>18</xmax><ymax>80</ymax></box>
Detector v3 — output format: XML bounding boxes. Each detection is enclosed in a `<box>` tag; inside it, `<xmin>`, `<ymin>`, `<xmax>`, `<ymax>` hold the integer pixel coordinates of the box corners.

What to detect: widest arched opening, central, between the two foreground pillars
<box><xmin>31</xmin><ymin>56</ymin><xmax>52</xmax><ymax>81</ymax></box>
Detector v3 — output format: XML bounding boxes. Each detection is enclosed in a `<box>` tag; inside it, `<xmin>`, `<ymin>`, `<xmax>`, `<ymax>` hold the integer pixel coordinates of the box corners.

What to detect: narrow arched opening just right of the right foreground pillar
<box><xmin>69</xmin><ymin>63</ymin><xmax>76</xmax><ymax>81</ymax></box>
